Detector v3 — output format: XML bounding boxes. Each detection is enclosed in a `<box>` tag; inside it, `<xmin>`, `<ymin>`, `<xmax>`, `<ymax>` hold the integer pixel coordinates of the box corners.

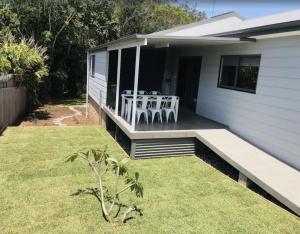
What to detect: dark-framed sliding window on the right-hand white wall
<box><xmin>218</xmin><ymin>55</ymin><xmax>260</xmax><ymax>93</ymax></box>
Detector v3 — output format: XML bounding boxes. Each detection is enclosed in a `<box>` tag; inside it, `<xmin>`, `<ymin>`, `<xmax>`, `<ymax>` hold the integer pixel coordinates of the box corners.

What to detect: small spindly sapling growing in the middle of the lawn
<box><xmin>66</xmin><ymin>149</ymin><xmax>143</xmax><ymax>224</ymax></box>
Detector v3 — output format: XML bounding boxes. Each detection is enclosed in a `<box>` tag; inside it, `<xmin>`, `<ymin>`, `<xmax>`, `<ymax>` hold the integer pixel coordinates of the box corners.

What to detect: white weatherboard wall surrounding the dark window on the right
<box><xmin>174</xmin><ymin>36</ymin><xmax>300</xmax><ymax>169</ymax></box>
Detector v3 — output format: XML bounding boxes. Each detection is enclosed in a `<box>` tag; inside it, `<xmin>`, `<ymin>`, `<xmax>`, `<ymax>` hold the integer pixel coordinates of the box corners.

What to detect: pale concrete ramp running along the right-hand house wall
<box><xmin>196</xmin><ymin>129</ymin><xmax>300</xmax><ymax>215</ymax></box>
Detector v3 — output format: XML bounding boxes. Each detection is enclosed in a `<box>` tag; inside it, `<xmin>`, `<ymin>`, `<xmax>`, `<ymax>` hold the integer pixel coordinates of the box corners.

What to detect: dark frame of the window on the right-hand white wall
<box><xmin>217</xmin><ymin>54</ymin><xmax>261</xmax><ymax>94</ymax></box>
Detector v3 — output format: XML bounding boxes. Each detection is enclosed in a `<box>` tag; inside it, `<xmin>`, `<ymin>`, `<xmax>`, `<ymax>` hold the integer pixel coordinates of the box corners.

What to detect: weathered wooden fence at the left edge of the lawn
<box><xmin>0</xmin><ymin>87</ymin><xmax>26</xmax><ymax>129</ymax></box>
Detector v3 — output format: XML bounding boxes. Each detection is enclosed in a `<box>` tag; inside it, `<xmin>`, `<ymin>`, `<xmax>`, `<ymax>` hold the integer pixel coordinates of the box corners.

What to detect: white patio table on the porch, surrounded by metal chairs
<box><xmin>121</xmin><ymin>94</ymin><xmax>179</xmax><ymax>122</ymax></box>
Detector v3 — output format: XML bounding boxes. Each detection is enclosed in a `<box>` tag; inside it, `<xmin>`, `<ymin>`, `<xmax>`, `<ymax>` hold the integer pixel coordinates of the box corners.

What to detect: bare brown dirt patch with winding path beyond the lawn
<box><xmin>19</xmin><ymin>105</ymin><xmax>99</xmax><ymax>127</ymax></box>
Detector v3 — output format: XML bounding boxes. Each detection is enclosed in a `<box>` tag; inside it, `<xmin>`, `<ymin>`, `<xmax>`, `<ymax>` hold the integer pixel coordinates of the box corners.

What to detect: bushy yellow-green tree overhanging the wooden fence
<box><xmin>0</xmin><ymin>38</ymin><xmax>48</xmax><ymax>107</ymax></box>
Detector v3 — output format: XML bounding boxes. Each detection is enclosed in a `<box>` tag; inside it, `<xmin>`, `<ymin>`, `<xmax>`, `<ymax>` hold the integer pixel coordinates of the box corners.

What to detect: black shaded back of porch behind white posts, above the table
<box><xmin>107</xmin><ymin>48</ymin><xmax>166</xmax><ymax>109</ymax></box>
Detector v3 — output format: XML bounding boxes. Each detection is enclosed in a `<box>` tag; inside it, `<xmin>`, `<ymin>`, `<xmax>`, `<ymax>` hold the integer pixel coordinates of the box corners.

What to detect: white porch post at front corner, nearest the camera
<box><xmin>131</xmin><ymin>45</ymin><xmax>141</xmax><ymax>130</ymax></box>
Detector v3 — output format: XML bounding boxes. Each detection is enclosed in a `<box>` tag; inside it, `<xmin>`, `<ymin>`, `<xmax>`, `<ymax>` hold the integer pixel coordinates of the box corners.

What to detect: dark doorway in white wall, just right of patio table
<box><xmin>176</xmin><ymin>56</ymin><xmax>201</xmax><ymax>111</ymax></box>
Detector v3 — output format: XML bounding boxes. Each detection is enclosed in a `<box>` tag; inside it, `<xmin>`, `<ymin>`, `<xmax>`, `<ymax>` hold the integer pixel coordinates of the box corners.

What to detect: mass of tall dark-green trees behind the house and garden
<box><xmin>0</xmin><ymin>0</ymin><xmax>204</xmax><ymax>97</ymax></box>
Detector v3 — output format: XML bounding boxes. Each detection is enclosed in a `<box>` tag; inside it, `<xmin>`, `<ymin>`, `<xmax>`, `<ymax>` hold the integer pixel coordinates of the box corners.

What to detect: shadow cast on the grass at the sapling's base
<box><xmin>71</xmin><ymin>188</ymin><xmax>143</xmax><ymax>223</ymax></box>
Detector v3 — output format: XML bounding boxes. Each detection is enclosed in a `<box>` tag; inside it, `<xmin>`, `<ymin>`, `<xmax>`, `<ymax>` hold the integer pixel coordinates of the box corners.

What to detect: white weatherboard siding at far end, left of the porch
<box><xmin>89</xmin><ymin>51</ymin><xmax>108</xmax><ymax>105</ymax></box>
